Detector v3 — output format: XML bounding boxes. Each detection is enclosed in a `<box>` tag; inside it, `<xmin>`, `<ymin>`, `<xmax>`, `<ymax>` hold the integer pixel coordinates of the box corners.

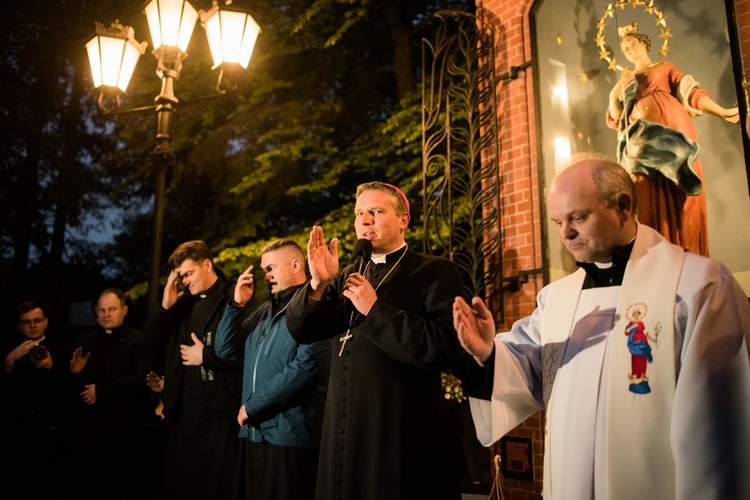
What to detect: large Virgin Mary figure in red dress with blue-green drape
<box><xmin>607</xmin><ymin>23</ymin><xmax>739</xmax><ymax>256</ymax></box>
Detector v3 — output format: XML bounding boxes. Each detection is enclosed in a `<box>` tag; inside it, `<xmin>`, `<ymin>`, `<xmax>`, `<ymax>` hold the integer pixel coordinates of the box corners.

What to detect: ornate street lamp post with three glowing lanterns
<box><xmin>86</xmin><ymin>0</ymin><xmax>260</xmax><ymax>311</ymax></box>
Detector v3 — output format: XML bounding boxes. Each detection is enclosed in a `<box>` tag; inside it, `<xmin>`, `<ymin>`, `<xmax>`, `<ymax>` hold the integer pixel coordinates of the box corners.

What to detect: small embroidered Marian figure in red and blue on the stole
<box><xmin>625</xmin><ymin>302</ymin><xmax>661</xmax><ymax>394</ymax></box>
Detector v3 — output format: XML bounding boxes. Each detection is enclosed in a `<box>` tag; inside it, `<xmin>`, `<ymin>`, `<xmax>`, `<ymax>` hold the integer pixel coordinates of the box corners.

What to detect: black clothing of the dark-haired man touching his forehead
<box><xmin>144</xmin><ymin>274</ymin><xmax>242</xmax><ymax>499</ymax></box>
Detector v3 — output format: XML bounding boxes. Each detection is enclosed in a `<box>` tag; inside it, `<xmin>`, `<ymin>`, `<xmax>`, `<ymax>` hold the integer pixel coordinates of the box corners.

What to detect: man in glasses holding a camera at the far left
<box><xmin>0</xmin><ymin>301</ymin><xmax>68</xmax><ymax>499</ymax></box>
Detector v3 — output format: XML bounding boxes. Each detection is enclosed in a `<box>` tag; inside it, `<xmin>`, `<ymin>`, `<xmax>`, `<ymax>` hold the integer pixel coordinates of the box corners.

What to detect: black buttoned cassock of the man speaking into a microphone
<box><xmin>286</xmin><ymin>248</ymin><xmax>461</xmax><ymax>500</ymax></box>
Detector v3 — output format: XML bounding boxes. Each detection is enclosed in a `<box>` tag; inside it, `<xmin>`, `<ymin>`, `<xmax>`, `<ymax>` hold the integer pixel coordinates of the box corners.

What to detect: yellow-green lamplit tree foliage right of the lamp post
<box><xmin>96</xmin><ymin>0</ymin><xmax>465</xmax><ymax>310</ymax></box>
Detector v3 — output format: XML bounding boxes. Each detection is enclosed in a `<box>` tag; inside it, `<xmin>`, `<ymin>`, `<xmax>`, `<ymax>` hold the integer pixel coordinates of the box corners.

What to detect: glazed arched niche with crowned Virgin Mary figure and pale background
<box><xmin>532</xmin><ymin>0</ymin><xmax>750</xmax><ymax>294</ymax></box>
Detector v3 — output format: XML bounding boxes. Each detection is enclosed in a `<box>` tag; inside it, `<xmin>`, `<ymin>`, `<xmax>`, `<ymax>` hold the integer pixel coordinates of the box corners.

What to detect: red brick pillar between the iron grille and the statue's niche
<box><xmin>476</xmin><ymin>0</ymin><xmax>544</xmax><ymax>500</ymax></box>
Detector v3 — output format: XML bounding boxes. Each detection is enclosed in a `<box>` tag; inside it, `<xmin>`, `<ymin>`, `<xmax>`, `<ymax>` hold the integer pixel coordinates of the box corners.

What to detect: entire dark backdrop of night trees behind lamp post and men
<box><xmin>0</xmin><ymin>0</ymin><xmax>473</xmax><ymax>324</ymax></box>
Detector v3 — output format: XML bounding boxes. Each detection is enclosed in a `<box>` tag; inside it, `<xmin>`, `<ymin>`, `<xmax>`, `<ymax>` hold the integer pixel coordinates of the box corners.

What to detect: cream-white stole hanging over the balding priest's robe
<box><xmin>541</xmin><ymin>224</ymin><xmax>685</xmax><ymax>499</ymax></box>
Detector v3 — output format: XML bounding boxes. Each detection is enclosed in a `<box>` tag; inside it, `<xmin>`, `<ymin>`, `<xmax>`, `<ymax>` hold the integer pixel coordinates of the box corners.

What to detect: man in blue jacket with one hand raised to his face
<box><xmin>216</xmin><ymin>240</ymin><xmax>329</xmax><ymax>499</ymax></box>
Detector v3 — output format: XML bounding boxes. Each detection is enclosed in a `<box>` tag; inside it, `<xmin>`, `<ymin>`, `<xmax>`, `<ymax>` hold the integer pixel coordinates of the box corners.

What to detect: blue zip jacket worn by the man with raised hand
<box><xmin>215</xmin><ymin>285</ymin><xmax>330</xmax><ymax>447</ymax></box>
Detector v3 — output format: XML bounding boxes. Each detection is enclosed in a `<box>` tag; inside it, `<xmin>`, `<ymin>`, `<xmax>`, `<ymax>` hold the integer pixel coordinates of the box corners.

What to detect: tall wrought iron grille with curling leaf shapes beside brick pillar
<box><xmin>422</xmin><ymin>11</ymin><xmax>502</xmax><ymax>315</ymax></box>
